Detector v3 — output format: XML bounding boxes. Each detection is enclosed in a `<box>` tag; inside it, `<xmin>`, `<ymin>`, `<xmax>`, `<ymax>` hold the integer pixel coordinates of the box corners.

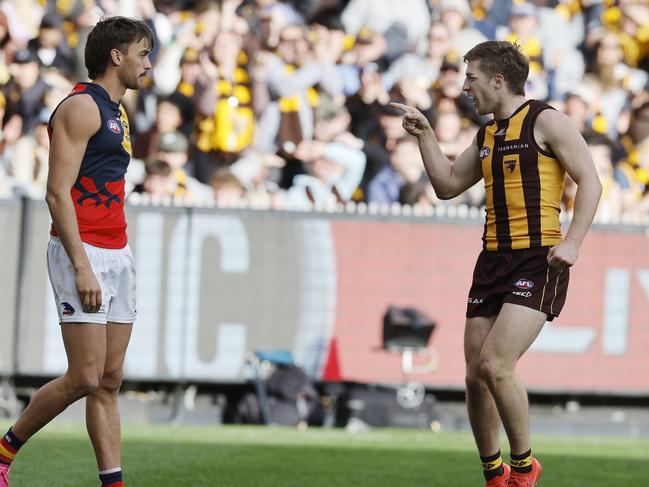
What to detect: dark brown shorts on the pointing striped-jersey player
<box><xmin>466</xmin><ymin>247</ymin><xmax>570</xmax><ymax>321</ymax></box>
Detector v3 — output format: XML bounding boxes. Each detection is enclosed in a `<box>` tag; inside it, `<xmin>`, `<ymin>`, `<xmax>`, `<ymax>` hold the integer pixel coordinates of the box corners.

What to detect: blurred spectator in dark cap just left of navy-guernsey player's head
<box><xmin>27</xmin><ymin>11</ymin><xmax>76</xmax><ymax>76</ymax></box>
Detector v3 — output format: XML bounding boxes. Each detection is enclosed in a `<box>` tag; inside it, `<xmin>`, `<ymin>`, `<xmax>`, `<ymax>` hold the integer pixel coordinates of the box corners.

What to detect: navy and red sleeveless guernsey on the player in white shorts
<box><xmin>48</xmin><ymin>83</ymin><xmax>131</xmax><ymax>249</ymax></box>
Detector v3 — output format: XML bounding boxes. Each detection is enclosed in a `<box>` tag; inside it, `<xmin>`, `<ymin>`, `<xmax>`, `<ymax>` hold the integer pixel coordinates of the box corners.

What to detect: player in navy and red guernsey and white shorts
<box><xmin>0</xmin><ymin>16</ymin><xmax>154</xmax><ymax>487</ymax></box>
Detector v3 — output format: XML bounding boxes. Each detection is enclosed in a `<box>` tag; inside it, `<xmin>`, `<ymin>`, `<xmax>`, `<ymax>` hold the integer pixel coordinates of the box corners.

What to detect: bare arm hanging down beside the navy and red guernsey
<box><xmin>45</xmin><ymin>95</ymin><xmax>101</xmax><ymax>313</ymax></box>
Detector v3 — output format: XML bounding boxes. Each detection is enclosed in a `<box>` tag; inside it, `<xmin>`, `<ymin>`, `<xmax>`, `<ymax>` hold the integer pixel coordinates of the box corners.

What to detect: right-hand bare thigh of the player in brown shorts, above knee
<box><xmin>482</xmin><ymin>303</ymin><xmax>547</xmax><ymax>364</ymax></box>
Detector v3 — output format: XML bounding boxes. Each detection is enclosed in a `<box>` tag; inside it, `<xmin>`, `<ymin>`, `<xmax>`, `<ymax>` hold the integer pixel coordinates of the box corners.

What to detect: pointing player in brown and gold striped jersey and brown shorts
<box><xmin>391</xmin><ymin>41</ymin><xmax>602</xmax><ymax>487</ymax></box>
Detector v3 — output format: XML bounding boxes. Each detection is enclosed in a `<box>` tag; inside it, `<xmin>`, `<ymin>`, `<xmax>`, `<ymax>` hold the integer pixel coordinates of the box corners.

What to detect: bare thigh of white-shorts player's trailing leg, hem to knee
<box><xmin>61</xmin><ymin>323</ymin><xmax>106</xmax><ymax>380</ymax></box>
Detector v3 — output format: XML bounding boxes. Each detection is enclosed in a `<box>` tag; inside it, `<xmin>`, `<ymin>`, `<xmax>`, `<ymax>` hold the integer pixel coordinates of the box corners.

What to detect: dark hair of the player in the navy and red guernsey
<box><xmin>85</xmin><ymin>16</ymin><xmax>154</xmax><ymax>79</ymax></box>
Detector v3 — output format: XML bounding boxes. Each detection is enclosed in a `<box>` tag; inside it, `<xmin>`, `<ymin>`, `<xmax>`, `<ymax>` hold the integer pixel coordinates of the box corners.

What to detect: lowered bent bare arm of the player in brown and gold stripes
<box><xmin>534</xmin><ymin>110</ymin><xmax>602</xmax><ymax>267</ymax></box>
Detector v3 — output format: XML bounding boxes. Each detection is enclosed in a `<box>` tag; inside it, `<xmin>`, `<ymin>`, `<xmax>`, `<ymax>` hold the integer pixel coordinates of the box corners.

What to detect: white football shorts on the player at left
<box><xmin>47</xmin><ymin>237</ymin><xmax>136</xmax><ymax>324</ymax></box>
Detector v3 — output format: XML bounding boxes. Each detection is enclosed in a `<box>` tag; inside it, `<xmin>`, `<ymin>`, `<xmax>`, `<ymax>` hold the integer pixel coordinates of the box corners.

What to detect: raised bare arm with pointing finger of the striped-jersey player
<box><xmin>390</xmin><ymin>102</ymin><xmax>482</xmax><ymax>199</ymax></box>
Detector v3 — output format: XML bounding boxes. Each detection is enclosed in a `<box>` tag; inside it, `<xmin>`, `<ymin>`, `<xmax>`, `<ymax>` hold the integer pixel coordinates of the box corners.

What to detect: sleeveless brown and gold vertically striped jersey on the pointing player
<box><xmin>477</xmin><ymin>100</ymin><xmax>565</xmax><ymax>250</ymax></box>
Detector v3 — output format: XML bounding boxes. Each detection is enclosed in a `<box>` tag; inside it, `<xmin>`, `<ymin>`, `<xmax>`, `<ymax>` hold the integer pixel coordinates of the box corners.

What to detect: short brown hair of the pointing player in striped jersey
<box><xmin>464</xmin><ymin>41</ymin><xmax>530</xmax><ymax>96</ymax></box>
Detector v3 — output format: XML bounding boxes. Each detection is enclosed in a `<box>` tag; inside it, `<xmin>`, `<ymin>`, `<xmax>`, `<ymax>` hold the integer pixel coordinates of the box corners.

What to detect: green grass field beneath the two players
<box><xmin>0</xmin><ymin>420</ymin><xmax>649</xmax><ymax>487</ymax></box>
